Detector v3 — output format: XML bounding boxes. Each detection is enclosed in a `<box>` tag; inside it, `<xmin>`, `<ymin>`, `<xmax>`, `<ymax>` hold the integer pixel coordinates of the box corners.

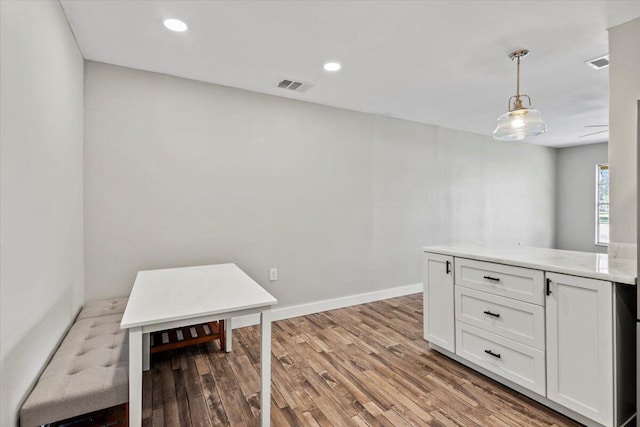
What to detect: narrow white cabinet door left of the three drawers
<box><xmin>423</xmin><ymin>253</ymin><xmax>456</xmax><ymax>353</ymax></box>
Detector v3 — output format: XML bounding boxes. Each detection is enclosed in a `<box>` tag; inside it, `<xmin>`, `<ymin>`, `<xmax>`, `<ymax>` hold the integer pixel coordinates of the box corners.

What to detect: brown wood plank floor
<box><xmin>143</xmin><ymin>294</ymin><xmax>578</xmax><ymax>427</ymax></box>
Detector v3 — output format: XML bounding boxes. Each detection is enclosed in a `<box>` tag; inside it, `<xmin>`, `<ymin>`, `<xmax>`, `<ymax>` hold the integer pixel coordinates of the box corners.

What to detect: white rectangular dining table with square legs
<box><xmin>120</xmin><ymin>264</ymin><xmax>278</xmax><ymax>427</ymax></box>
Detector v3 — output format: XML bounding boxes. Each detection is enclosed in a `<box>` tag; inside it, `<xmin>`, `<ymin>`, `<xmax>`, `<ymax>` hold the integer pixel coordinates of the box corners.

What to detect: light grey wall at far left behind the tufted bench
<box><xmin>0</xmin><ymin>0</ymin><xmax>84</xmax><ymax>427</ymax></box>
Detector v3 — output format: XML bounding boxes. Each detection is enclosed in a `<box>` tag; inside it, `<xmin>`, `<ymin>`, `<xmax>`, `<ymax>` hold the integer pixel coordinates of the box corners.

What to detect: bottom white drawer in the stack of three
<box><xmin>456</xmin><ymin>322</ymin><xmax>546</xmax><ymax>396</ymax></box>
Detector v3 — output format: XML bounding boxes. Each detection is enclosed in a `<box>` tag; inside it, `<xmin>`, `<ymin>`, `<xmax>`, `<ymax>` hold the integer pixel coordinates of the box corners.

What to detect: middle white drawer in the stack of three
<box><xmin>455</xmin><ymin>286</ymin><xmax>544</xmax><ymax>351</ymax></box>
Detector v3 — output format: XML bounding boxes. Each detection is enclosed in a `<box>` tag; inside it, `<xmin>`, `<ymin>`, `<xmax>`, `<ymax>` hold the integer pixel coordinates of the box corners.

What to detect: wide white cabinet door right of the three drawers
<box><xmin>546</xmin><ymin>273</ymin><xmax>613</xmax><ymax>426</ymax></box>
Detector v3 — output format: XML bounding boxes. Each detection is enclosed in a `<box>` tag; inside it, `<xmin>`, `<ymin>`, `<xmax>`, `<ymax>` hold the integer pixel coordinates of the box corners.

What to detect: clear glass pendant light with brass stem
<box><xmin>493</xmin><ymin>49</ymin><xmax>547</xmax><ymax>141</ymax></box>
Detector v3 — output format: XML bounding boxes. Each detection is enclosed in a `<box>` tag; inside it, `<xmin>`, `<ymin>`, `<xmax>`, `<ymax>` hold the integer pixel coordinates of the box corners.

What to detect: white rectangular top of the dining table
<box><xmin>120</xmin><ymin>264</ymin><xmax>278</xmax><ymax>328</ymax></box>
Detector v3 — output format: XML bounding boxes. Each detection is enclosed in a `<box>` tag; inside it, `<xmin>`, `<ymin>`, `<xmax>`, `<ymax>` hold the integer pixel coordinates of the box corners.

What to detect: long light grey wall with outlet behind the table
<box><xmin>85</xmin><ymin>62</ymin><xmax>555</xmax><ymax>306</ymax></box>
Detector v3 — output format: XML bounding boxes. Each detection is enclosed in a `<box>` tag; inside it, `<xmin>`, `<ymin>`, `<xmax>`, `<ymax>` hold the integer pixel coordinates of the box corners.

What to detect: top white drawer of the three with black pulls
<box><xmin>455</xmin><ymin>258</ymin><xmax>544</xmax><ymax>305</ymax></box>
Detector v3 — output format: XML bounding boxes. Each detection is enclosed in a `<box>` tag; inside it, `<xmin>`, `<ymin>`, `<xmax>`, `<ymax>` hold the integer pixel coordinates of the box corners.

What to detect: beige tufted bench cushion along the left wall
<box><xmin>20</xmin><ymin>313</ymin><xmax>129</xmax><ymax>427</ymax></box>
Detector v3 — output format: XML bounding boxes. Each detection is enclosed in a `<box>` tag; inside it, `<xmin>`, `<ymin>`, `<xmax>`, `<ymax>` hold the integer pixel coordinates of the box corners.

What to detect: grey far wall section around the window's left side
<box><xmin>556</xmin><ymin>142</ymin><xmax>608</xmax><ymax>253</ymax></box>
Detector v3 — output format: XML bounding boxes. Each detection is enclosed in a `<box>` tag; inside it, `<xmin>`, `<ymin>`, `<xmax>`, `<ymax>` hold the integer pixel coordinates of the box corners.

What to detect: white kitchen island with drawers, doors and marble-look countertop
<box><xmin>423</xmin><ymin>244</ymin><xmax>636</xmax><ymax>427</ymax></box>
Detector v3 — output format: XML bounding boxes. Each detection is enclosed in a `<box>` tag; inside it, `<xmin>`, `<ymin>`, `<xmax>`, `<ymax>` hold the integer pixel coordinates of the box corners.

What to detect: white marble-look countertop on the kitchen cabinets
<box><xmin>423</xmin><ymin>244</ymin><xmax>637</xmax><ymax>285</ymax></box>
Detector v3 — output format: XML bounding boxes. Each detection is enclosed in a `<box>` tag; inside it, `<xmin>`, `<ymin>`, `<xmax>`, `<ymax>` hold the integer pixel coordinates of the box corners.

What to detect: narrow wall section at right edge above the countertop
<box><xmin>609</xmin><ymin>18</ymin><xmax>640</xmax><ymax>254</ymax></box>
